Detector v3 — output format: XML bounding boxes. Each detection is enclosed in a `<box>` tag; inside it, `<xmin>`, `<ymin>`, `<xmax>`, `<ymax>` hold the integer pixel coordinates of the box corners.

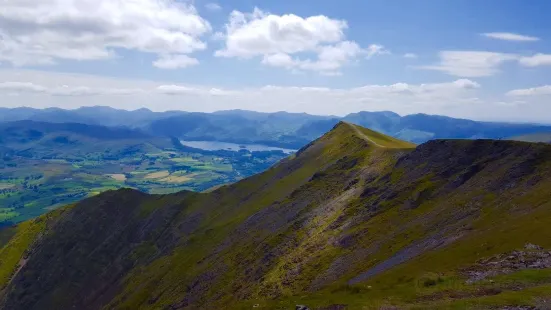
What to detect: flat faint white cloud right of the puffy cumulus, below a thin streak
<box><xmin>419</xmin><ymin>51</ymin><xmax>519</xmax><ymax>77</ymax></box>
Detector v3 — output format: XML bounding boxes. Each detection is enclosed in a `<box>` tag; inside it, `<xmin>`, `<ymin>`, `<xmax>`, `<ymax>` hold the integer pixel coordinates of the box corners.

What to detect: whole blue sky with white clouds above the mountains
<box><xmin>0</xmin><ymin>0</ymin><xmax>551</xmax><ymax>123</ymax></box>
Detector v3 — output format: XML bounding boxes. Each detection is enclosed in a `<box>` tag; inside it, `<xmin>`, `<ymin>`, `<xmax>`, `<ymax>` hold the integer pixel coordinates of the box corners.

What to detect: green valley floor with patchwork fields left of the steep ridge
<box><xmin>0</xmin><ymin>141</ymin><xmax>285</xmax><ymax>225</ymax></box>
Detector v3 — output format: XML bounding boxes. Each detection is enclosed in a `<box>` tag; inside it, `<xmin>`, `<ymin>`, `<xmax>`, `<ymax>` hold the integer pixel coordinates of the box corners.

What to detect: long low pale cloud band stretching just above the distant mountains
<box><xmin>0</xmin><ymin>70</ymin><xmax>490</xmax><ymax>115</ymax></box>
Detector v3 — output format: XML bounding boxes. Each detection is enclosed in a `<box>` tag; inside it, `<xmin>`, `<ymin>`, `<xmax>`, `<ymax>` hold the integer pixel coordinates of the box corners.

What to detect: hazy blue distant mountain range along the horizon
<box><xmin>0</xmin><ymin>106</ymin><xmax>551</xmax><ymax>148</ymax></box>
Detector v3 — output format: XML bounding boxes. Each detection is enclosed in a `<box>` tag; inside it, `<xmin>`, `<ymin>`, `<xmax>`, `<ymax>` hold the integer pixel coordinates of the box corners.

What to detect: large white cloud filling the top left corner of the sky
<box><xmin>0</xmin><ymin>0</ymin><xmax>211</xmax><ymax>66</ymax></box>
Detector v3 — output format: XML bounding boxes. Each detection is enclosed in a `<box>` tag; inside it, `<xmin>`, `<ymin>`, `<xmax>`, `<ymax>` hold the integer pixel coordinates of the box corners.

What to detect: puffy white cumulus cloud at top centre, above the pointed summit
<box><xmin>215</xmin><ymin>8</ymin><xmax>388</xmax><ymax>75</ymax></box>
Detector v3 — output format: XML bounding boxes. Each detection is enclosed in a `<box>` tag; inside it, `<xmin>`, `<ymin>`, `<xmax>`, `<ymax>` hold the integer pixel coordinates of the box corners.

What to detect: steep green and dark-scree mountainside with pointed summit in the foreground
<box><xmin>0</xmin><ymin>122</ymin><xmax>551</xmax><ymax>309</ymax></box>
